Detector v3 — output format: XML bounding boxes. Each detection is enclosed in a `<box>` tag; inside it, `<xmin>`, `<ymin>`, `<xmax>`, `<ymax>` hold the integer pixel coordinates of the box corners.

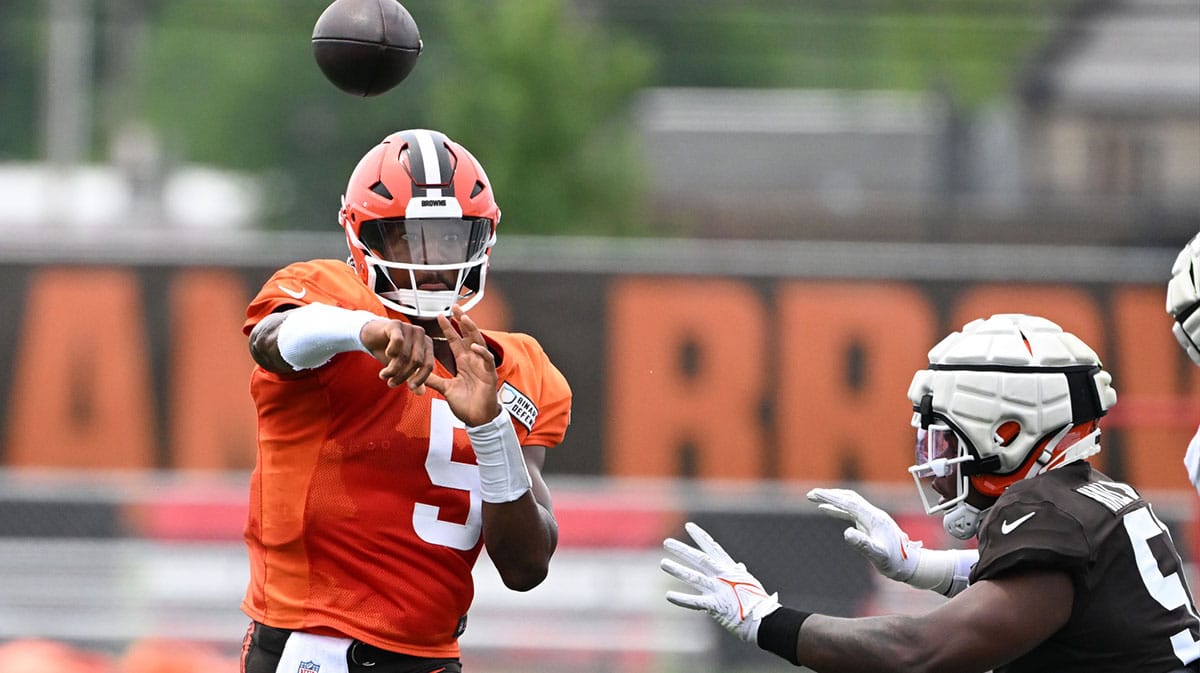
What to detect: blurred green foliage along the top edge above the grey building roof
<box><xmin>596</xmin><ymin>0</ymin><xmax>1078</xmax><ymax>107</ymax></box>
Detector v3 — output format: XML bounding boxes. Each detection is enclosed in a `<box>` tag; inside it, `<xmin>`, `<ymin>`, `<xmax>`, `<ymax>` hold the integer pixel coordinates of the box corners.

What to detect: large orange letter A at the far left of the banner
<box><xmin>5</xmin><ymin>269</ymin><xmax>158</xmax><ymax>469</ymax></box>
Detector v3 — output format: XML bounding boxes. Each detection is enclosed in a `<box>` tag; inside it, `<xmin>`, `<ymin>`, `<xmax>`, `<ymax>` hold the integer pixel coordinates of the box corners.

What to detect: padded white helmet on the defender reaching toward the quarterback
<box><xmin>908</xmin><ymin>314</ymin><xmax>1117</xmax><ymax>540</ymax></box>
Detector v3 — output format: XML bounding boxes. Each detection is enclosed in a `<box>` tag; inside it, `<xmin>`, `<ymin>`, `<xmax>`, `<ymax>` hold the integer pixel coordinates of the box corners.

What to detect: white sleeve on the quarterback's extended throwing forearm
<box><xmin>275</xmin><ymin>304</ymin><xmax>384</xmax><ymax>371</ymax></box>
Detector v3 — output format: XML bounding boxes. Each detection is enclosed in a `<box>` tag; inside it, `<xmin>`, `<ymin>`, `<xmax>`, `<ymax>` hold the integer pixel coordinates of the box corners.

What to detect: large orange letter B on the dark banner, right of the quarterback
<box><xmin>605</xmin><ymin>278</ymin><xmax>770</xmax><ymax>479</ymax></box>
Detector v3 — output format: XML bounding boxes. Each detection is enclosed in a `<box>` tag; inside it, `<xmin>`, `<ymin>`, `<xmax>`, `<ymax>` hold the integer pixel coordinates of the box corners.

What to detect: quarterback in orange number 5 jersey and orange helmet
<box><xmin>242</xmin><ymin>130</ymin><xmax>571</xmax><ymax>673</ymax></box>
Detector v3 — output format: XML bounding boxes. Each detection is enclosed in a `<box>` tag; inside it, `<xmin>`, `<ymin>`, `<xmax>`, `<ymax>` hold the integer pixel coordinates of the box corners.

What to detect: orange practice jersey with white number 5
<box><xmin>242</xmin><ymin>260</ymin><xmax>571</xmax><ymax>656</ymax></box>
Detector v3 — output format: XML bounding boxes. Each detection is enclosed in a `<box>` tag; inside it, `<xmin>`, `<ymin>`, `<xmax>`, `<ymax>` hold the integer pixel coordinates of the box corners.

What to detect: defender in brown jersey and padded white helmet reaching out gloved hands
<box><xmin>662</xmin><ymin>314</ymin><xmax>1200</xmax><ymax>673</ymax></box>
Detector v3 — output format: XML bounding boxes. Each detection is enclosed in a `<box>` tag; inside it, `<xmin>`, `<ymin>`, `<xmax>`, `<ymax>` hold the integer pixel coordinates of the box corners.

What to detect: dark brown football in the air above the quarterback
<box><xmin>312</xmin><ymin>0</ymin><xmax>422</xmax><ymax>96</ymax></box>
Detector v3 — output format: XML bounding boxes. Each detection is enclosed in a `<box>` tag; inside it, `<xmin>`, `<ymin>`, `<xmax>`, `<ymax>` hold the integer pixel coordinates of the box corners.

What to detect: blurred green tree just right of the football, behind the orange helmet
<box><xmin>430</xmin><ymin>0</ymin><xmax>650</xmax><ymax>234</ymax></box>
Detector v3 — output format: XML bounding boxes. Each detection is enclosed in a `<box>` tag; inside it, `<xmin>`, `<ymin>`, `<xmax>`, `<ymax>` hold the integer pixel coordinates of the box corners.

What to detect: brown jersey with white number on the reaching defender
<box><xmin>971</xmin><ymin>462</ymin><xmax>1200</xmax><ymax>673</ymax></box>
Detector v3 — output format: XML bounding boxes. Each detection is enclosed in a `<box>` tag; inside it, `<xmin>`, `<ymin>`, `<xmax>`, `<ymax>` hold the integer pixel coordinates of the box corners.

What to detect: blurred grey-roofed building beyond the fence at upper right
<box><xmin>638</xmin><ymin>0</ymin><xmax>1200</xmax><ymax>245</ymax></box>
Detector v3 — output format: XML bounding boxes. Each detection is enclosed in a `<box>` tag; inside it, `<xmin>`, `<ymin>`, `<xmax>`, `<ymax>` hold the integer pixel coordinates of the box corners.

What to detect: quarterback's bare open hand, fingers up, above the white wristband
<box><xmin>425</xmin><ymin>306</ymin><xmax>500</xmax><ymax>426</ymax></box>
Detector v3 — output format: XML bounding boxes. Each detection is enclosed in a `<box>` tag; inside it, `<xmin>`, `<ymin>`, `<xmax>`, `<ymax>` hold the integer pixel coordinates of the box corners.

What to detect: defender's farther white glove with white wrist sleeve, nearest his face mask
<box><xmin>808</xmin><ymin>488</ymin><xmax>979</xmax><ymax>596</ymax></box>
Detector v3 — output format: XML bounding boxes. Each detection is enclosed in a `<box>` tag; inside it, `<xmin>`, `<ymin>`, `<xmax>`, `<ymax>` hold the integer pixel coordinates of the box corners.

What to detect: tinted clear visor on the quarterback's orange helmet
<box><xmin>359</xmin><ymin>217</ymin><xmax>492</xmax><ymax>269</ymax></box>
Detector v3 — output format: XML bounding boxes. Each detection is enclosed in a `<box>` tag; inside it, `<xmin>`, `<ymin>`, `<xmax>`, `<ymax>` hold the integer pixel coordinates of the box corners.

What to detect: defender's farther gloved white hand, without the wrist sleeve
<box><xmin>808</xmin><ymin>488</ymin><xmax>924</xmax><ymax>582</ymax></box>
